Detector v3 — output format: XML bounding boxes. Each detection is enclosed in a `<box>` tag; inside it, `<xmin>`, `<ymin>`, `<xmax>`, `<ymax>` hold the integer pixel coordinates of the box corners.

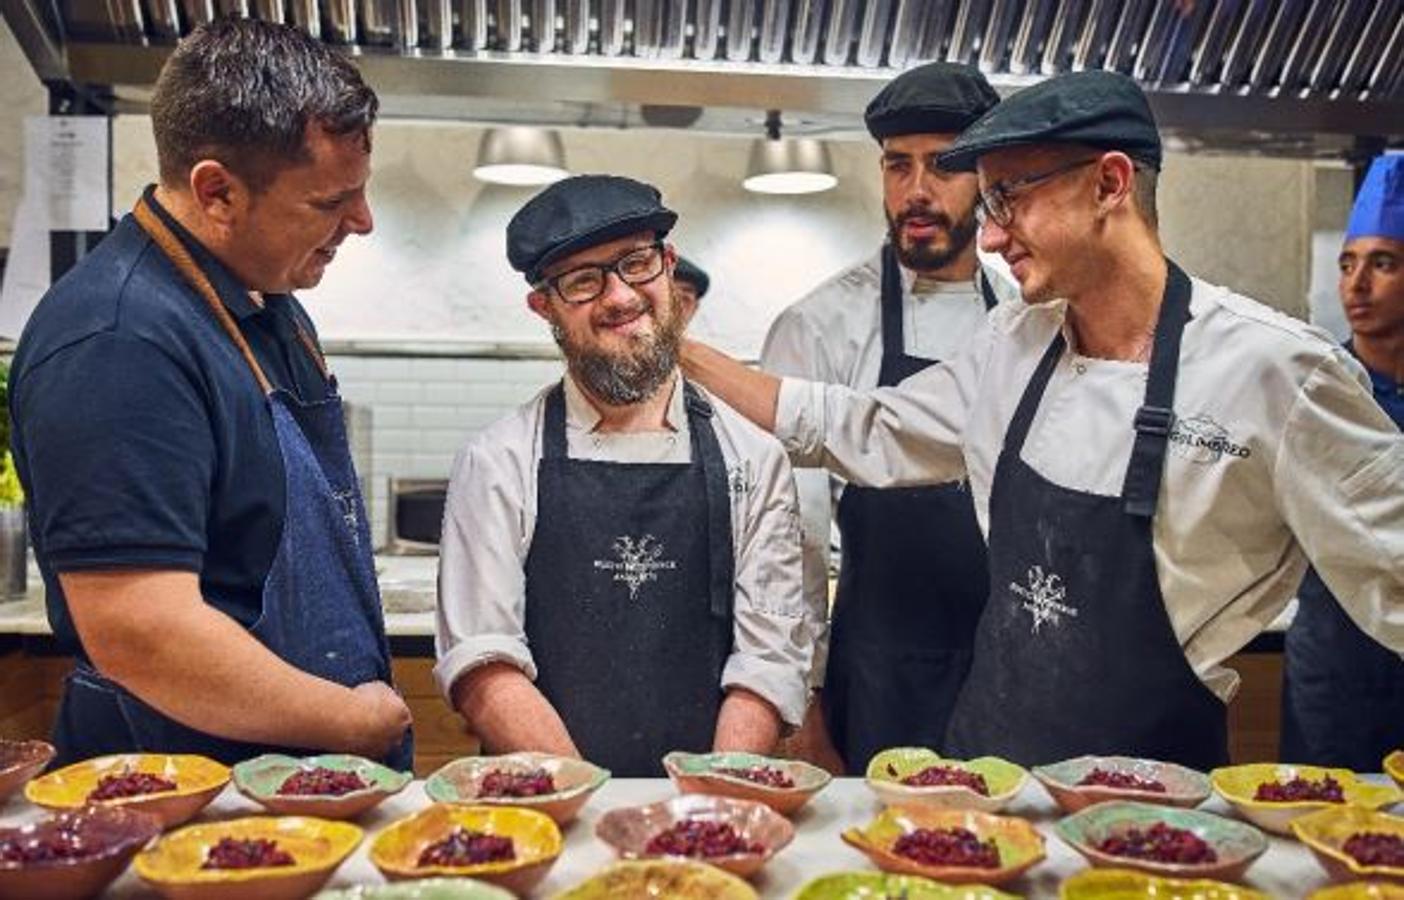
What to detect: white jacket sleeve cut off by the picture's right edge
<box><xmin>1273</xmin><ymin>351</ymin><xmax>1404</xmax><ymax>653</ymax></box>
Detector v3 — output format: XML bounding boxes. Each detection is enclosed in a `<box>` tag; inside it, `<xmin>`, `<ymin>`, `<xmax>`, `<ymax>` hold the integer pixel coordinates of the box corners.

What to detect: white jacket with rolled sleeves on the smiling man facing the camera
<box><xmin>434</xmin><ymin>375</ymin><xmax>824</xmax><ymax>726</ymax></box>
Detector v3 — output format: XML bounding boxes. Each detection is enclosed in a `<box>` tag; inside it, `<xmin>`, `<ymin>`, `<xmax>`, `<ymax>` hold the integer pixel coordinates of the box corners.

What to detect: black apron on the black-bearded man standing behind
<box><xmin>823</xmin><ymin>244</ymin><xmax>994</xmax><ymax>775</ymax></box>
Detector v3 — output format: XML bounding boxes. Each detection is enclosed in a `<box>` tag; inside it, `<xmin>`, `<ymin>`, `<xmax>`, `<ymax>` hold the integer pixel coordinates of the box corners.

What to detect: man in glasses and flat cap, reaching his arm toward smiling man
<box><xmin>673</xmin><ymin>72</ymin><xmax>1404</xmax><ymax>768</ymax></box>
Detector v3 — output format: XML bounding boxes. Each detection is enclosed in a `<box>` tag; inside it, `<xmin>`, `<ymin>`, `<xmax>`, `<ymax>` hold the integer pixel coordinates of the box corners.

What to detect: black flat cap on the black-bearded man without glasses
<box><xmin>863</xmin><ymin>62</ymin><xmax>1000</xmax><ymax>143</ymax></box>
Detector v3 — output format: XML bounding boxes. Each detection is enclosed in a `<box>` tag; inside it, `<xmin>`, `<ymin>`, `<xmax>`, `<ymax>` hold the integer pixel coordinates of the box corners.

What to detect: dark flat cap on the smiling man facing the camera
<box><xmin>507</xmin><ymin>176</ymin><xmax>678</xmax><ymax>285</ymax></box>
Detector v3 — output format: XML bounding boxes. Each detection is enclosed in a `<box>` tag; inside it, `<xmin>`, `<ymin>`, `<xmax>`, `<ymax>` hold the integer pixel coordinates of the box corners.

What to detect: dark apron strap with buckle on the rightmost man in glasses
<box><xmin>1122</xmin><ymin>260</ymin><xmax>1192</xmax><ymax>520</ymax></box>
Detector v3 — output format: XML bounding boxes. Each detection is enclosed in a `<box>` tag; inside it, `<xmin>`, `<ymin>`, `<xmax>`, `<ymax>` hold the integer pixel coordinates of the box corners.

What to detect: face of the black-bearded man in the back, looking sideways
<box><xmin>882</xmin><ymin>135</ymin><xmax>976</xmax><ymax>272</ymax></box>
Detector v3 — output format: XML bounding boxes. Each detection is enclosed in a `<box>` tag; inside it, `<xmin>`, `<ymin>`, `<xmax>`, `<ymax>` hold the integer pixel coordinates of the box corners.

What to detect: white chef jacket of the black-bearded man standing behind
<box><xmin>761</xmin><ymin>250</ymin><xmax>1018</xmax><ymax>687</ymax></box>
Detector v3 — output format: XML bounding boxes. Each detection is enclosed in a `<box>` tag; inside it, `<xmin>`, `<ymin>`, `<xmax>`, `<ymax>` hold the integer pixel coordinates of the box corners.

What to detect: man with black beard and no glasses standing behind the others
<box><xmin>761</xmin><ymin>62</ymin><xmax>998</xmax><ymax>775</ymax></box>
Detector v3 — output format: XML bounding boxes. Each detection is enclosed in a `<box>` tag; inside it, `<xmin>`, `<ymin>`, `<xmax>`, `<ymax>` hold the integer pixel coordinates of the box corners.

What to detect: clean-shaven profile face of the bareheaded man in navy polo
<box><xmin>230</xmin><ymin>125</ymin><xmax>373</xmax><ymax>293</ymax></box>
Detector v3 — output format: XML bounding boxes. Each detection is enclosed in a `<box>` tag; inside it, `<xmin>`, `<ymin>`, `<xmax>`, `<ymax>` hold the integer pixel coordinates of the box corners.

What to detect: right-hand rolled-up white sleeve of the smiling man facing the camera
<box><xmin>722</xmin><ymin>444</ymin><xmax>824</xmax><ymax>727</ymax></box>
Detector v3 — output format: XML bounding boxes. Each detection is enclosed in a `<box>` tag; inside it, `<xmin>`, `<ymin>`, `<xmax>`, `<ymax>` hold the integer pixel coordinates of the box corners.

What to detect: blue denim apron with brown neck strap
<box><xmin>55</xmin><ymin>199</ymin><xmax>414</xmax><ymax>771</ymax></box>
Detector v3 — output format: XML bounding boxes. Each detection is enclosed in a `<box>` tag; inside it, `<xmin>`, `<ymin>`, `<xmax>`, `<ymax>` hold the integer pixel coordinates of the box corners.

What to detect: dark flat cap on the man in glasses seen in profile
<box><xmin>938</xmin><ymin>70</ymin><xmax>1161</xmax><ymax>171</ymax></box>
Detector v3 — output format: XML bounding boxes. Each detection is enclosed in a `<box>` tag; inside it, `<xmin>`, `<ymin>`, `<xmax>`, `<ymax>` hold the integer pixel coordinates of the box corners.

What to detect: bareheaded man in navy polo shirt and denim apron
<box><xmin>11</xmin><ymin>20</ymin><xmax>411</xmax><ymax>768</ymax></box>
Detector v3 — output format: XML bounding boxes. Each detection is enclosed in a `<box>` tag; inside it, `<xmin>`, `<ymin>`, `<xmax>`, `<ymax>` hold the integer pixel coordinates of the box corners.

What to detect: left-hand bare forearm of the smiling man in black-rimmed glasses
<box><xmin>452</xmin><ymin>663</ymin><xmax>580</xmax><ymax>758</ymax></box>
